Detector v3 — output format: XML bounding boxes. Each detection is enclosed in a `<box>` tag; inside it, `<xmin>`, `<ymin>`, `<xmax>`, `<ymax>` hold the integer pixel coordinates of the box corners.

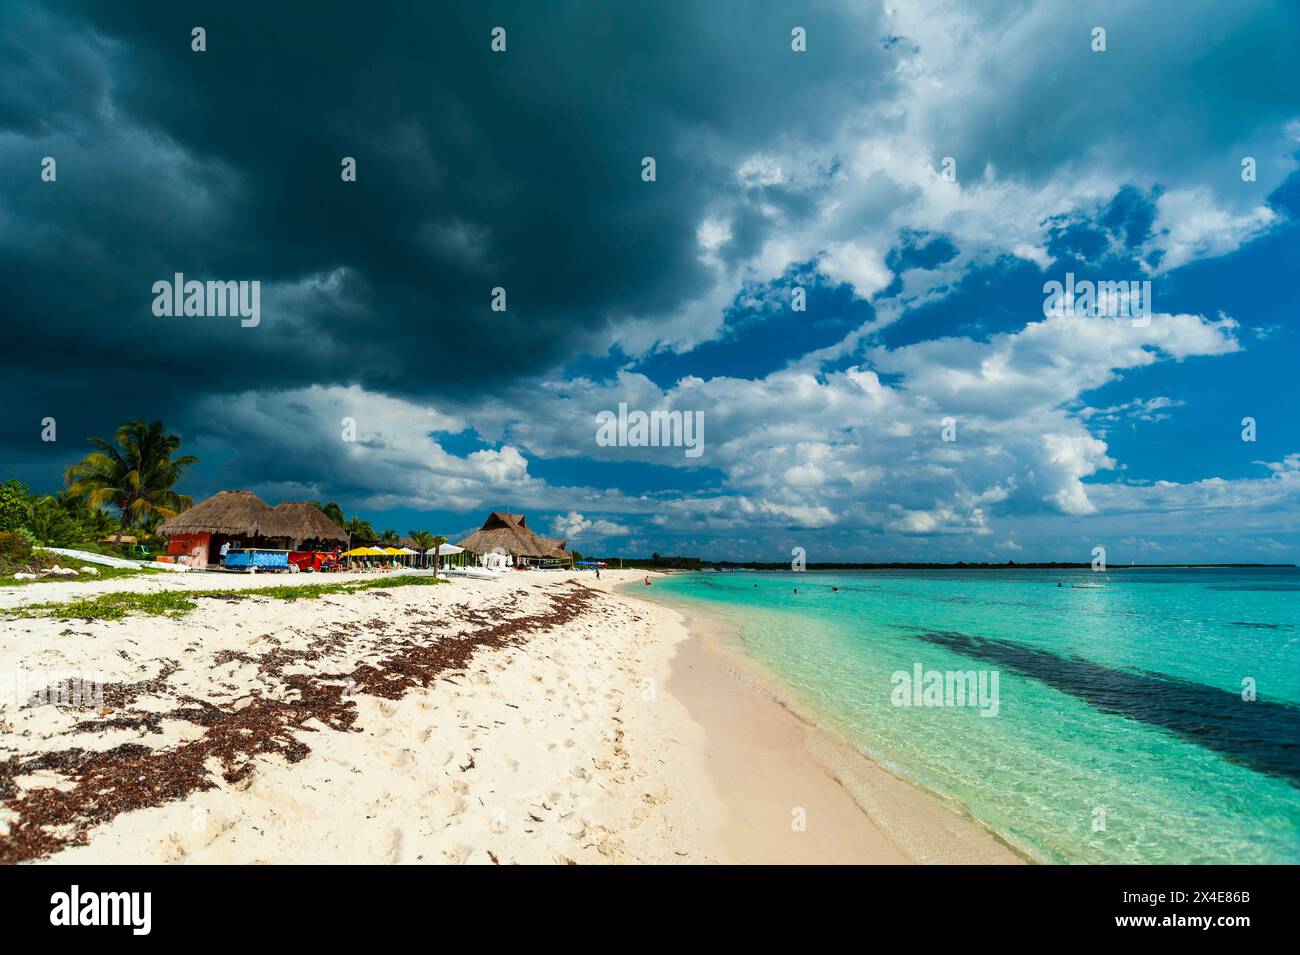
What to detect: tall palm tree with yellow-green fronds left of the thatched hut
<box><xmin>64</xmin><ymin>421</ymin><xmax>199</xmax><ymax>546</ymax></box>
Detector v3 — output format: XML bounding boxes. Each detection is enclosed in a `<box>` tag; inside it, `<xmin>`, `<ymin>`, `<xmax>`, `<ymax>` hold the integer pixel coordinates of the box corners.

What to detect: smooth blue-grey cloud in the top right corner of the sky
<box><xmin>922</xmin><ymin>0</ymin><xmax>1300</xmax><ymax>183</ymax></box>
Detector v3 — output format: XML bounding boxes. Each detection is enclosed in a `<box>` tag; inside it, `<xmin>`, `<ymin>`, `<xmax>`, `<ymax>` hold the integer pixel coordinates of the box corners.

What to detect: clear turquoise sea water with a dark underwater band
<box><xmin>655</xmin><ymin>569</ymin><xmax>1300</xmax><ymax>863</ymax></box>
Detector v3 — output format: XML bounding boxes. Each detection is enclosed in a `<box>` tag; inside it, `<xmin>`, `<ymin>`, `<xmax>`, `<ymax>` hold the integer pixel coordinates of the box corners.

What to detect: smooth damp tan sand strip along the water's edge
<box><xmin>618</xmin><ymin>574</ymin><xmax>1037</xmax><ymax>865</ymax></box>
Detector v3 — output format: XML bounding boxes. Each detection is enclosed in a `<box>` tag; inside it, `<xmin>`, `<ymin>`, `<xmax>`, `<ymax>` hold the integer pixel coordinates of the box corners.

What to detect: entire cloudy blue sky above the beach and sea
<box><xmin>0</xmin><ymin>0</ymin><xmax>1300</xmax><ymax>563</ymax></box>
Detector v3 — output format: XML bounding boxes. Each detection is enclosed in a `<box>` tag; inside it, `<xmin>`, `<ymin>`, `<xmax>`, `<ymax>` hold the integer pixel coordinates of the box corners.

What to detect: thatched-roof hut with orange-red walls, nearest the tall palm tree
<box><xmin>159</xmin><ymin>491</ymin><xmax>298</xmax><ymax>568</ymax></box>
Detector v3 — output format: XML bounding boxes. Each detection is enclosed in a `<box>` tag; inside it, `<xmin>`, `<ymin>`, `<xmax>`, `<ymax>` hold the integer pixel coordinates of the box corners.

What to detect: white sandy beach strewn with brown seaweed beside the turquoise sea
<box><xmin>0</xmin><ymin>570</ymin><xmax>1018</xmax><ymax>864</ymax></box>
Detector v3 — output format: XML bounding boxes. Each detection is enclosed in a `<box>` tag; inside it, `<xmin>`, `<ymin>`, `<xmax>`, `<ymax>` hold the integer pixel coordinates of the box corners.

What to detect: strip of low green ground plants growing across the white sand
<box><xmin>4</xmin><ymin>574</ymin><xmax>443</xmax><ymax>620</ymax></box>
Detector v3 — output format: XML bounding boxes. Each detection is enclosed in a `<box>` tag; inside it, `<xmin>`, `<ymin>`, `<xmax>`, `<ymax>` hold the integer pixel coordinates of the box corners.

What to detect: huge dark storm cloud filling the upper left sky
<box><xmin>0</xmin><ymin>3</ymin><xmax>892</xmax><ymax>467</ymax></box>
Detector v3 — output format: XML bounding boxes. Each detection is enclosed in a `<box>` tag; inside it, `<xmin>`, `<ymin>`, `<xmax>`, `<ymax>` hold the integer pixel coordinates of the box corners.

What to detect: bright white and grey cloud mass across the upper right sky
<box><xmin>600</xmin><ymin>0</ymin><xmax>1300</xmax><ymax>359</ymax></box>
